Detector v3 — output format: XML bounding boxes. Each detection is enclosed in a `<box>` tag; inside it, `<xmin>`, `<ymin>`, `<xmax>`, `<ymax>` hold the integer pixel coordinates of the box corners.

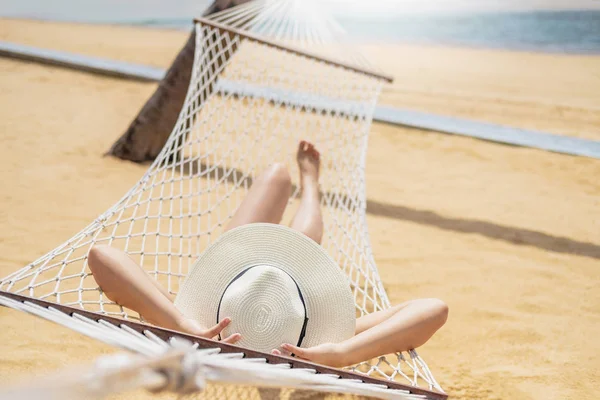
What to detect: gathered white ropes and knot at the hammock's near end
<box><xmin>0</xmin><ymin>294</ymin><xmax>445</xmax><ymax>400</ymax></box>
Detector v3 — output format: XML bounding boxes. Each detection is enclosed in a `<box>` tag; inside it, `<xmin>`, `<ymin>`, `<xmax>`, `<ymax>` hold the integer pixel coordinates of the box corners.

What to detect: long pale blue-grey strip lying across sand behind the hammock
<box><xmin>0</xmin><ymin>41</ymin><xmax>600</xmax><ymax>159</ymax></box>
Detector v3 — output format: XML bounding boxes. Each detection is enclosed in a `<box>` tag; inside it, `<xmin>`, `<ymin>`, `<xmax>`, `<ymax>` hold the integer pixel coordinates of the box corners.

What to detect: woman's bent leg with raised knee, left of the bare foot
<box><xmin>225</xmin><ymin>163</ymin><xmax>292</xmax><ymax>232</ymax></box>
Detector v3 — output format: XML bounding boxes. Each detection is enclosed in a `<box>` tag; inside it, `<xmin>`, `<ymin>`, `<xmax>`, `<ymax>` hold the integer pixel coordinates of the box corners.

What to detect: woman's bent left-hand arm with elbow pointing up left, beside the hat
<box><xmin>88</xmin><ymin>245</ymin><xmax>241</xmax><ymax>343</ymax></box>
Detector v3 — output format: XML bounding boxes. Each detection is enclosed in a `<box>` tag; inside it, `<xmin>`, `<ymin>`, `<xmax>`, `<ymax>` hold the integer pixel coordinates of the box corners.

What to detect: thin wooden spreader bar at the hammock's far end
<box><xmin>194</xmin><ymin>18</ymin><xmax>394</xmax><ymax>83</ymax></box>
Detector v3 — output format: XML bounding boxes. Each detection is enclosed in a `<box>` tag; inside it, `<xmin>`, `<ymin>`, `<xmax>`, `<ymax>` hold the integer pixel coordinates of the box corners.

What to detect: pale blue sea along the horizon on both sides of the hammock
<box><xmin>0</xmin><ymin>9</ymin><xmax>600</xmax><ymax>55</ymax></box>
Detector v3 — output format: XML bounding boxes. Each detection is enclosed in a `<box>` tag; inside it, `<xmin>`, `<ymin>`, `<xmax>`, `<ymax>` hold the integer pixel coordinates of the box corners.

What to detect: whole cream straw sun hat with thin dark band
<box><xmin>175</xmin><ymin>224</ymin><xmax>356</xmax><ymax>352</ymax></box>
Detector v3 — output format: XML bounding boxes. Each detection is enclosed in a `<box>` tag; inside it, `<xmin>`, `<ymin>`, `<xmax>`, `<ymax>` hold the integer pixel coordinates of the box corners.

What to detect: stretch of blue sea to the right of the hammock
<box><xmin>341</xmin><ymin>10</ymin><xmax>600</xmax><ymax>54</ymax></box>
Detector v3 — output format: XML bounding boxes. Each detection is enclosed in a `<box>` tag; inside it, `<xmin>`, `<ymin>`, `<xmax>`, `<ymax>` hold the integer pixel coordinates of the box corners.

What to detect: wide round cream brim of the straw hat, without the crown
<box><xmin>175</xmin><ymin>223</ymin><xmax>356</xmax><ymax>347</ymax></box>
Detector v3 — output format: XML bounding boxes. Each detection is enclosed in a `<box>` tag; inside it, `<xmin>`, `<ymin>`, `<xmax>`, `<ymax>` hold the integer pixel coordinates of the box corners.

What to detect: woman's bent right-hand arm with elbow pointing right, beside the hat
<box><xmin>274</xmin><ymin>299</ymin><xmax>448</xmax><ymax>367</ymax></box>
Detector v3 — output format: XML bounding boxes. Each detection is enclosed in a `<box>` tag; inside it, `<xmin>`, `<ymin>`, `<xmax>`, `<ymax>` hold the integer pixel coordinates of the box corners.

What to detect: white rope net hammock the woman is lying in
<box><xmin>0</xmin><ymin>0</ymin><xmax>441</xmax><ymax>398</ymax></box>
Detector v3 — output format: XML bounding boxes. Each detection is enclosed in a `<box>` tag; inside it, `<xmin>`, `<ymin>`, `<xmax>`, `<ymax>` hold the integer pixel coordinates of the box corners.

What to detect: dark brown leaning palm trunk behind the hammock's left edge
<box><xmin>106</xmin><ymin>0</ymin><xmax>249</xmax><ymax>162</ymax></box>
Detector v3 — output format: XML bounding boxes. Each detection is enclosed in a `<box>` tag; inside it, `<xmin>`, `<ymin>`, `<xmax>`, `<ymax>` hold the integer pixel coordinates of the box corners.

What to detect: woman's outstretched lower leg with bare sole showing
<box><xmin>290</xmin><ymin>141</ymin><xmax>323</xmax><ymax>244</ymax></box>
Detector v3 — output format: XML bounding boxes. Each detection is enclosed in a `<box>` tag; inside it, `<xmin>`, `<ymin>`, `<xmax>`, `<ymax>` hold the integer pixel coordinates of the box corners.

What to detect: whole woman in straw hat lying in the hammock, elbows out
<box><xmin>88</xmin><ymin>141</ymin><xmax>448</xmax><ymax>367</ymax></box>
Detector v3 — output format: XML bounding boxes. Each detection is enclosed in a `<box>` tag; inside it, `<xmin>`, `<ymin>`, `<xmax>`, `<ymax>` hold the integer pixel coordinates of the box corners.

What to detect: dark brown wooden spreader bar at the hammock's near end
<box><xmin>0</xmin><ymin>290</ymin><xmax>448</xmax><ymax>400</ymax></box>
